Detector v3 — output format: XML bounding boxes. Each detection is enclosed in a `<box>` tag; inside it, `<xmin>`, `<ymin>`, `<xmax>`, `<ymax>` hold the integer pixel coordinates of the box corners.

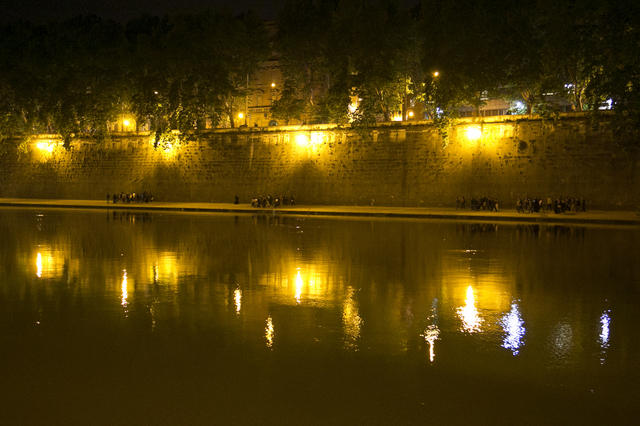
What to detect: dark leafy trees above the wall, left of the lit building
<box><xmin>0</xmin><ymin>8</ymin><xmax>269</xmax><ymax>141</ymax></box>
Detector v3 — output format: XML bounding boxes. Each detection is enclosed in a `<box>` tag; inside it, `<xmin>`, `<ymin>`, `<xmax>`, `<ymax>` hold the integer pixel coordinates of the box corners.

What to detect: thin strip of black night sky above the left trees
<box><xmin>0</xmin><ymin>0</ymin><xmax>282</xmax><ymax>22</ymax></box>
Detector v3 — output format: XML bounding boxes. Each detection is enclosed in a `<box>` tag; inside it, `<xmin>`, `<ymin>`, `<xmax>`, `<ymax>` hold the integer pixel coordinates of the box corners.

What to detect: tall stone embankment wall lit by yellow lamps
<box><xmin>0</xmin><ymin>116</ymin><xmax>640</xmax><ymax>208</ymax></box>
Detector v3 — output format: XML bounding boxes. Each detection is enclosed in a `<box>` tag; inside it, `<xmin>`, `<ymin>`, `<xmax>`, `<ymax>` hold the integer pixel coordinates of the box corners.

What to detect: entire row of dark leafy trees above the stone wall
<box><xmin>0</xmin><ymin>0</ymin><xmax>640</xmax><ymax>140</ymax></box>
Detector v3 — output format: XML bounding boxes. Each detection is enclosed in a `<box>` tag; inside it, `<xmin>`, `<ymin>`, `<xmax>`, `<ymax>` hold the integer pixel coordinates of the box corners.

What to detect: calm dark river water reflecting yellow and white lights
<box><xmin>0</xmin><ymin>209</ymin><xmax>640</xmax><ymax>424</ymax></box>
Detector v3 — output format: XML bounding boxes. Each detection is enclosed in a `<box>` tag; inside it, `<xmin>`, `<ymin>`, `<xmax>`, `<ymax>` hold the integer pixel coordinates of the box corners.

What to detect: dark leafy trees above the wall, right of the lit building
<box><xmin>278</xmin><ymin>0</ymin><xmax>640</xmax><ymax>130</ymax></box>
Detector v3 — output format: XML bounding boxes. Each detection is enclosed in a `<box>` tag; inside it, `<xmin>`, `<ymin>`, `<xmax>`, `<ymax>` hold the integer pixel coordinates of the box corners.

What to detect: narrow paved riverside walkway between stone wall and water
<box><xmin>0</xmin><ymin>198</ymin><xmax>640</xmax><ymax>226</ymax></box>
